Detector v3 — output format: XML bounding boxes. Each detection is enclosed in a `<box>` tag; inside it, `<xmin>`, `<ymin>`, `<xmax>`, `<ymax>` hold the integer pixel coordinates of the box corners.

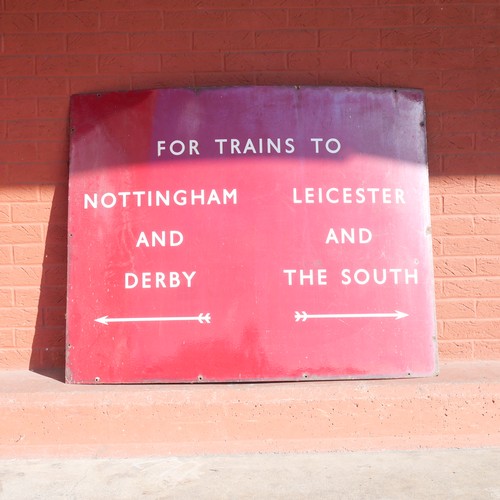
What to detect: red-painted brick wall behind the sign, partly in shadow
<box><xmin>0</xmin><ymin>0</ymin><xmax>500</xmax><ymax>369</ymax></box>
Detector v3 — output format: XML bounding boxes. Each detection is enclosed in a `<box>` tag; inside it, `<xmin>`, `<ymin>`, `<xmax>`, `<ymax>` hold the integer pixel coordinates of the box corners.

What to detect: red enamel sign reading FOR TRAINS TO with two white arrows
<box><xmin>66</xmin><ymin>87</ymin><xmax>436</xmax><ymax>383</ymax></box>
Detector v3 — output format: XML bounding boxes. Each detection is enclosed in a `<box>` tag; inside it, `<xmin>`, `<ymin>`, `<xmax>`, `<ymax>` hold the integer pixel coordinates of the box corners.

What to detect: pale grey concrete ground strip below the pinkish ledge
<box><xmin>0</xmin><ymin>448</ymin><xmax>500</xmax><ymax>500</ymax></box>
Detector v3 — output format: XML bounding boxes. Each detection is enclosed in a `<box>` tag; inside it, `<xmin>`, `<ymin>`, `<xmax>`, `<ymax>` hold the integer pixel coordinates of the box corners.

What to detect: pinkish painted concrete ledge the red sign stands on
<box><xmin>0</xmin><ymin>361</ymin><xmax>500</xmax><ymax>457</ymax></box>
